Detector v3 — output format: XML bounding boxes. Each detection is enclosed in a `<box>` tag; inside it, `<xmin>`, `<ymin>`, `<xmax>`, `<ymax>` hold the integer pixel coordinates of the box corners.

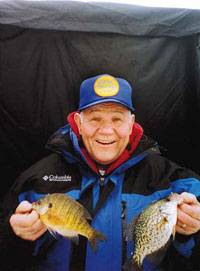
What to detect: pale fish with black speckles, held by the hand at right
<box><xmin>123</xmin><ymin>193</ymin><xmax>182</xmax><ymax>271</ymax></box>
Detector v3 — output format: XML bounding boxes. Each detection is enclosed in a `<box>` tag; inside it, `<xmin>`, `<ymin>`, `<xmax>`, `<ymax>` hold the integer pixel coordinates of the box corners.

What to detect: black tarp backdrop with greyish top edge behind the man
<box><xmin>0</xmin><ymin>1</ymin><xmax>200</xmax><ymax>202</ymax></box>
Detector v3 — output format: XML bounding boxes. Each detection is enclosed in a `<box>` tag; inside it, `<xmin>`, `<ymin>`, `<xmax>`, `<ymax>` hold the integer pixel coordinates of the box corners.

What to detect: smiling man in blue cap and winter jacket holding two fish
<box><xmin>0</xmin><ymin>75</ymin><xmax>200</xmax><ymax>271</ymax></box>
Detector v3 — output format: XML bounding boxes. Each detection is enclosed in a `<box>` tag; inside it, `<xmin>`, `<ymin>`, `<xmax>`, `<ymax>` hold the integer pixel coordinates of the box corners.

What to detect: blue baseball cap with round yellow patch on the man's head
<box><xmin>78</xmin><ymin>74</ymin><xmax>135</xmax><ymax>112</ymax></box>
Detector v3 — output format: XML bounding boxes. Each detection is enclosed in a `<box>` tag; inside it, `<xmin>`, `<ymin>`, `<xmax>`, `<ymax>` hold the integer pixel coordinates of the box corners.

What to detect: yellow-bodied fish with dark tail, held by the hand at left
<box><xmin>32</xmin><ymin>193</ymin><xmax>106</xmax><ymax>252</ymax></box>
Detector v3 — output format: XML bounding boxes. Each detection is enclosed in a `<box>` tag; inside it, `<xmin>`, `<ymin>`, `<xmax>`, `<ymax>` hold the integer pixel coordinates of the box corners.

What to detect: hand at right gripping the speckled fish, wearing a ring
<box><xmin>176</xmin><ymin>192</ymin><xmax>200</xmax><ymax>235</ymax></box>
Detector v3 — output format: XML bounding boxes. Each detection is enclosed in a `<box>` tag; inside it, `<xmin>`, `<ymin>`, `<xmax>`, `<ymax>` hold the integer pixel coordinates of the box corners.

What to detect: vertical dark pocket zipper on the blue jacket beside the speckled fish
<box><xmin>121</xmin><ymin>201</ymin><xmax>127</xmax><ymax>270</ymax></box>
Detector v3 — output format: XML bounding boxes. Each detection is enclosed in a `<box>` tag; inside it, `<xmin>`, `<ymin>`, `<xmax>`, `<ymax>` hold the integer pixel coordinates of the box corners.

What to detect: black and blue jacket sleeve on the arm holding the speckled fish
<box><xmin>146</xmin><ymin>155</ymin><xmax>200</xmax><ymax>271</ymax></box>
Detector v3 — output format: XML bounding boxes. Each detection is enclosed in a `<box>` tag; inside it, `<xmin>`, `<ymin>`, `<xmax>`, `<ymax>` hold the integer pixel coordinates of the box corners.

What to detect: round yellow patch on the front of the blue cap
<box><xmin>94</xmin><ymin>75</ymin><xmax>119</xmax><ymax>97</ymax></box>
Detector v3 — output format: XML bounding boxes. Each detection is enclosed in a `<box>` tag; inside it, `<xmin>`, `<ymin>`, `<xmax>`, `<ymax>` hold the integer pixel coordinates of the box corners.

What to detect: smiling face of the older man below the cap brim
<box><xmin>75</xmin><ymin>103</ymin><xmax>135</xmax><ymax>165</ymax></box>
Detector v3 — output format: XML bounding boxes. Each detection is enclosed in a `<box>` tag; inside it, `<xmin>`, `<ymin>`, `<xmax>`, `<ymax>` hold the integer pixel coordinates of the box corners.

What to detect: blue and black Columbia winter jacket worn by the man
<box><xmin>0</xmin><ymin>119</ymin><xmax>200</xmax><ymax>271</ymax></box>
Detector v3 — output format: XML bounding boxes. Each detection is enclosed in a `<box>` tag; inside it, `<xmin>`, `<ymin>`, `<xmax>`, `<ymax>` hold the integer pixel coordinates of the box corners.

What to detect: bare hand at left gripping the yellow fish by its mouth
<box><xmin>10</xmin><ymin>201</ymin><xmax>47</xmax><ymax>241</ymax></box>
